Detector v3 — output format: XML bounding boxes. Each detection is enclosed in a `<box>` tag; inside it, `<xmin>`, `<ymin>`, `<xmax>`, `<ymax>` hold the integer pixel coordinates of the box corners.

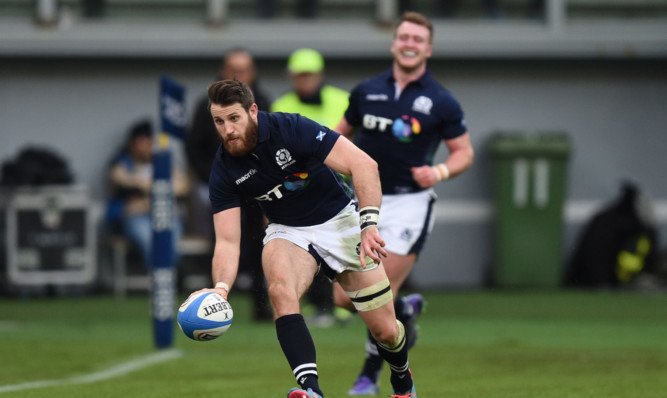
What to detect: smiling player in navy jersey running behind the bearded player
<box><xmin>335</xmin><ymin>12</ymin><xmax>473</xmax><ymax>395</ymax></box>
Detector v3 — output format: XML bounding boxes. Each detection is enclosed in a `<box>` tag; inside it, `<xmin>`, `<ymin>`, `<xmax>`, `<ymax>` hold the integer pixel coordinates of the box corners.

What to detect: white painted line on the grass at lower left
<box><xmin>0</xmin><ymin>349</ymin><xmax>183</xmax><ymax>394</ymax></box>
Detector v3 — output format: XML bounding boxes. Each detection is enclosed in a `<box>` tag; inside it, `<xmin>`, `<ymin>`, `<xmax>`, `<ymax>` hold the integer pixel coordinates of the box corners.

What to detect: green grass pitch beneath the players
<box><xmin>0</xmin><ymin>290</ymin><xmax>667</xmax><ymax>398</ymax></box>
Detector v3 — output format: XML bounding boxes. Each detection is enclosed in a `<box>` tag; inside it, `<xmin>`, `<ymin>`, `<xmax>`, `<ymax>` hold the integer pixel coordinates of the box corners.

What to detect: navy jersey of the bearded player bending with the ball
<box><xmin>209</xmin><ymin>111</ymin><xmax>351</xmax><ymax>227</ymax></box>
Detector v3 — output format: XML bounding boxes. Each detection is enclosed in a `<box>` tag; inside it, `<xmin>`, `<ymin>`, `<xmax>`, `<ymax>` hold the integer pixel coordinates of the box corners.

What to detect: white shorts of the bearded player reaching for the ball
<box><xmin>264</xmin><ymin>202</ymin><xmax>378</xmax><ymax>280</ymax></box>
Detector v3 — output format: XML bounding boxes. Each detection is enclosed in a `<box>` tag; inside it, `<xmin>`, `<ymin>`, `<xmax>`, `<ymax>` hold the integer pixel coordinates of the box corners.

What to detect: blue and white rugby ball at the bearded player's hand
<box><xmin>177</xmin><ymin>292</ymin><xmax>234</xmax><ymax>341</ymax></box>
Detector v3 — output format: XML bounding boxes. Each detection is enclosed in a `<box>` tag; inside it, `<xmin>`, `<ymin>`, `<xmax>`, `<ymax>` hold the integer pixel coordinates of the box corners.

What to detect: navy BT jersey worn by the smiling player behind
<box><xmin>345</xmin><ymin>69</ymin><xmax>467</xmax><ymax>194</ymax></box>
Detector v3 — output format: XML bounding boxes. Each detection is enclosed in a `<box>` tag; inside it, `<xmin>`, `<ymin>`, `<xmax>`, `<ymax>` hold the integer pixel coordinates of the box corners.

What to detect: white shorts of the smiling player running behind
<box><xmin>378</xmin><ymin>189</ymin><xmax>438</xmax><ymax>256</ymax></box>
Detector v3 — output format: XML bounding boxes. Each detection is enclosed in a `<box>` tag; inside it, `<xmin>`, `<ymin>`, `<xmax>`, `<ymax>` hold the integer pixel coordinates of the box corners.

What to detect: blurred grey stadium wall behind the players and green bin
<box><xmin>0</xmin><ymin>57</ymin><xmax>667</xmax><ymax>288</ymax></box>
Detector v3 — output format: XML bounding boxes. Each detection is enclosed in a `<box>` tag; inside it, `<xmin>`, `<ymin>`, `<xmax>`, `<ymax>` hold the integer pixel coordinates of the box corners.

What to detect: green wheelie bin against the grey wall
<box><xmin>489</xmin><ymin>131</ymin><xmax>571</xmax><ymax>287</ymax></box>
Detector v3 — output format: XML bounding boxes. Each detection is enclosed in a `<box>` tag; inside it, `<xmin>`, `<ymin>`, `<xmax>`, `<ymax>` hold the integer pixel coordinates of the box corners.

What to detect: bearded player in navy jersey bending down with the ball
<box><xmin>190</xmin><ymin>80</ymin><xmax>417</xmax><ymax>398</ymax></box>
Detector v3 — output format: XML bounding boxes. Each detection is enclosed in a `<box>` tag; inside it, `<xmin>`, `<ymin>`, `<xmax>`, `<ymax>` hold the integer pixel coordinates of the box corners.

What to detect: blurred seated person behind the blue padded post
<box><xmin>107</xmin><ymin>121</ymin><xmax>189</xmax><ymax>267</ymax></box>
